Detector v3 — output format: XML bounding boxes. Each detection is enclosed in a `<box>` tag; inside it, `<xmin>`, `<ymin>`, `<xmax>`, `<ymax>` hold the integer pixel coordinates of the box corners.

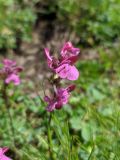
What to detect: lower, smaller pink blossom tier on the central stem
<box><xmin>44</xmin><ymin>85</ymin><xmax>75</xmax><ymax>112</ymax></box>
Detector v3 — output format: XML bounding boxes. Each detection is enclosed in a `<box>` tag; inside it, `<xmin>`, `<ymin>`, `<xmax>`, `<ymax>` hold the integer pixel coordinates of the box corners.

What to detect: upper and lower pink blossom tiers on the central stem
<box><xmin>44</xmin><ymin>42</ymin><xmax>80</xmax><ymax>112</ymax></box>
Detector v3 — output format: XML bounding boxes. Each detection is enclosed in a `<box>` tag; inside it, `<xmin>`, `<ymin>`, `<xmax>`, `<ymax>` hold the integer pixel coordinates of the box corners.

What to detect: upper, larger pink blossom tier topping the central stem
<box><xmin>45</xmin><ymin>42</ymin><xmax>80</xmax><ymax>80</ymax></box>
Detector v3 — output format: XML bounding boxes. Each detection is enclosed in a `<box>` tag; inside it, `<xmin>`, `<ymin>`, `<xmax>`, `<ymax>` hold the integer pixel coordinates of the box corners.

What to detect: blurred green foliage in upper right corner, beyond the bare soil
<box><xmin>56</xmin><ymin>0</ymin><xmax>120</xmax><ymax>45</ymax></box>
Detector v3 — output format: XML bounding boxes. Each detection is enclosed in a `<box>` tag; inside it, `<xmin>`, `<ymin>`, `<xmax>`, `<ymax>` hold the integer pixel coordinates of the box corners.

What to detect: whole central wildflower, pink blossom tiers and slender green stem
<box><xmin>44</xmin><ymin>42</ymin><xmax>80</xmax><ymax>160</ymax></box>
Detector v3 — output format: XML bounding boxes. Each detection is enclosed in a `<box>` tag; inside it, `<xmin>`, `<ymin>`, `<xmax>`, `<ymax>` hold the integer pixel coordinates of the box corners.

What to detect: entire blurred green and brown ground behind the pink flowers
<box><xmin>0</xmin><ymin>0</ymin><xmax>120</xmax><ymax>160</ymax></box>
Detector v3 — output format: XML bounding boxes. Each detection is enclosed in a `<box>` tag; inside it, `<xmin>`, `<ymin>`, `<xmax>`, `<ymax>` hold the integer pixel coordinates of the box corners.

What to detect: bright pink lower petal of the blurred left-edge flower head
<box><xmin>5</xmin><ymin>74</ymin><xmax>20</xmax><ymax>85</ymax></box>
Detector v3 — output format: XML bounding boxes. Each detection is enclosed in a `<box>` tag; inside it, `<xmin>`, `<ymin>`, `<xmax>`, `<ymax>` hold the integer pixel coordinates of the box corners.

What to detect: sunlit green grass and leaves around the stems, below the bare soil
<box><xmin>0</xmin><ymin>44</ymin><xmax>120</xmax><ymax>160</ymax></box>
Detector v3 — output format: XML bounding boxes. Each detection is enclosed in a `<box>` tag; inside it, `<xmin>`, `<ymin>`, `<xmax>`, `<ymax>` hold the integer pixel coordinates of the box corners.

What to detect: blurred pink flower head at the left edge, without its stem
<box><xmin>0</xmin><ymin>59</ymin><xmax>23</xmax><ymax>85</ymax></box>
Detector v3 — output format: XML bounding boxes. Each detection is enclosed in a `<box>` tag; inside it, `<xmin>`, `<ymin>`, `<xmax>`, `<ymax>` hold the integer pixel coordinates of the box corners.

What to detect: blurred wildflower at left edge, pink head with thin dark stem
<box><xmin>0</xmin><ymin>59</ymin><xmax>23</xmax><ymax>150</ymax></box>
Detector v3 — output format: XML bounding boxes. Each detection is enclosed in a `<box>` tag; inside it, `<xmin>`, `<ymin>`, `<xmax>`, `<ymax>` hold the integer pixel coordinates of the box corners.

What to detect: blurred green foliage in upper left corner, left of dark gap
<box><xmin>0</xmin><ymin>0</ymin><xmax>35</xmax><ymax>48</ymax></box>
